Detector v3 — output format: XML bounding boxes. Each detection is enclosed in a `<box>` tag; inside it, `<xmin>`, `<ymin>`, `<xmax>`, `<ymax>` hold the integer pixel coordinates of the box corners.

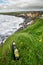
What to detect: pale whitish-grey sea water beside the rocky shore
<box><xmin>0</xmin><ymin>15</ymin><xmax>24</xmax><ymax>44</ymax></box>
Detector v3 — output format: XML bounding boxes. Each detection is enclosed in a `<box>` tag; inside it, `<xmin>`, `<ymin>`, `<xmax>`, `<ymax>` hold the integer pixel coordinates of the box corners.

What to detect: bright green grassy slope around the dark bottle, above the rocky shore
<box><xmin>0</xmin><ymin>19</ymin><xmax>43</xmax><ymax>65</ymax></box>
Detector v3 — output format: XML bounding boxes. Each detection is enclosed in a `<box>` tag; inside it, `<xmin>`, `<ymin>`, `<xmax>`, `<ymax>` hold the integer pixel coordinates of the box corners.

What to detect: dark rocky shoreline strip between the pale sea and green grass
<box><xmin>0</xmin><ymin>15</ymin><xmax>33</xmax><ymax>46</ymax></box>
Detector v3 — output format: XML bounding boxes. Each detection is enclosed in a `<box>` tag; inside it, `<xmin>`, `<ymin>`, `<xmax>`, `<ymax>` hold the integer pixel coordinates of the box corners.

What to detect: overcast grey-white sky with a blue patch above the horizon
<box><xmin>0</xmin><ymin>0</ymin><xmax>43</xmax><ymax>12</ymax></box>
